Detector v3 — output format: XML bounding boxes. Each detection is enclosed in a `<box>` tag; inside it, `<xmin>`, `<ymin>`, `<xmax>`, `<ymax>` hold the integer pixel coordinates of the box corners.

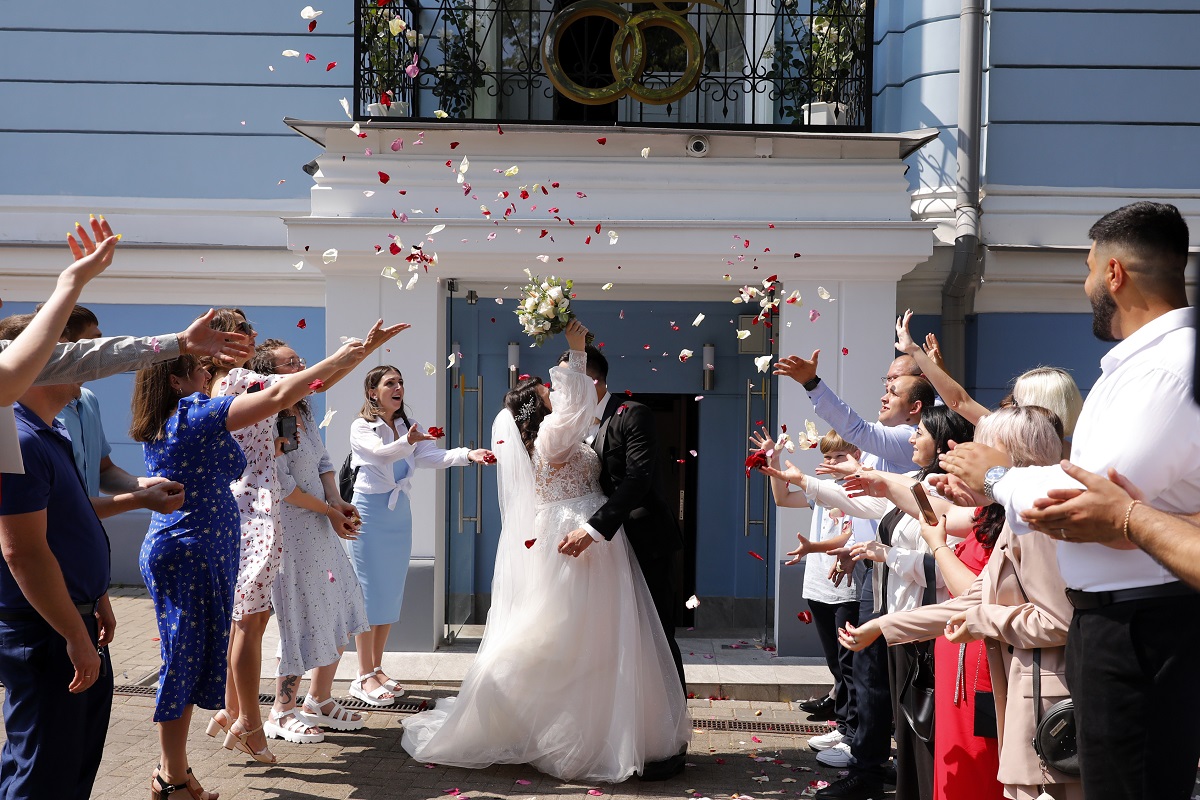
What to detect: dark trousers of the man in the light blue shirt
<box><xmin>850</xmin><ymin>560</ymin><xmax>892</xmax><ymax>778</ymax></box>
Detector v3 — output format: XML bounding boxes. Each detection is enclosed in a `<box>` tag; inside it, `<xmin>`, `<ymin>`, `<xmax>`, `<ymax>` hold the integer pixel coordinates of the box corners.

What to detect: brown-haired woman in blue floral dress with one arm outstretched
<box><xmin>130</xmin><ymin>342</ymin><xmax>364</xmax><ymax>800</ymax></box>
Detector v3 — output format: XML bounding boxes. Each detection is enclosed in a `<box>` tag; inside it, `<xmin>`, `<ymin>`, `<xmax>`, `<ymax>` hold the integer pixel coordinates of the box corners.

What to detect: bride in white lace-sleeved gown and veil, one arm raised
<box><xmin>402</xmin><ymin>320</ymin><xmax>691</xmax><ymax>783</ymax></box>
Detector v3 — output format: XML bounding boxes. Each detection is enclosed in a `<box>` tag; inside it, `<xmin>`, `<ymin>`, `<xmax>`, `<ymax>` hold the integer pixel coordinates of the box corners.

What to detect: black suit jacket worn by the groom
<box><xmin>588</xmin><ymin>396</ymin><xmax>683</xmax><ymax>558</ymax></box>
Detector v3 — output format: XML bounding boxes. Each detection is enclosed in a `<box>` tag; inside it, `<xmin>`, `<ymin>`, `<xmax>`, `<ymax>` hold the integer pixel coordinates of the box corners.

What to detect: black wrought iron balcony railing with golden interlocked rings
<box><xmin>354</xmin><ymin>0</ymin><xmax>874</xmax><ymax>131</ymax></box>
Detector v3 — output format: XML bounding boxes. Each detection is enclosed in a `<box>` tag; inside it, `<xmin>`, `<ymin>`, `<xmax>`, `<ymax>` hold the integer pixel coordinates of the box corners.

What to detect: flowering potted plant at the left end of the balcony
<box><xmin>362</xmin><ymin>6</ymin><xmax>421</xmax><ymax>116</ymax></box>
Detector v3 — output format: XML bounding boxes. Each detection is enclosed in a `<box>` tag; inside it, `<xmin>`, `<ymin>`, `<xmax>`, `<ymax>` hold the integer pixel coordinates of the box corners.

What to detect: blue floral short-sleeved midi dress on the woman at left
<box><xmin>138</xmin><ymin>392</ymin><xmax>246</xmax><ymax>722</ymax></box>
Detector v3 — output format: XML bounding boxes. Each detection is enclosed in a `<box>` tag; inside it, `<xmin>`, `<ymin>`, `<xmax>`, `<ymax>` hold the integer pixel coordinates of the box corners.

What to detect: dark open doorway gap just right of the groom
<box><xmin>634</xmin><ymin>395</ymin><xmax>700</xmax><ymax>627</ymax></box>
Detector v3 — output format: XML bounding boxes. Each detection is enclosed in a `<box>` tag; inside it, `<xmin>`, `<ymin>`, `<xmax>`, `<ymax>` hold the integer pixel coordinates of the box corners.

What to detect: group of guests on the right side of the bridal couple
<box><xmin>751</xmin><ymin>201</ymin><xmax>1200</xmax><ymax>800</ymax></box>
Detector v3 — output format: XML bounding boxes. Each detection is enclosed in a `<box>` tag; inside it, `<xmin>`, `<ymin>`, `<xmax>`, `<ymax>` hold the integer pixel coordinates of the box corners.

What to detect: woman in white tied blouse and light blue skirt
<box><xmin>349</xmin><ymin>365</ymin><xmax>496</xmax><ymax>705</ymax></box>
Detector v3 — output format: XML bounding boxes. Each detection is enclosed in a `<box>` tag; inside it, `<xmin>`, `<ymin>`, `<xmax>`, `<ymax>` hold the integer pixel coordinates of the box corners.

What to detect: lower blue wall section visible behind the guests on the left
<box><xmin>4</xmin><ymin>302</ymin><xmax>325</xmax><ymax>475</ymax></box>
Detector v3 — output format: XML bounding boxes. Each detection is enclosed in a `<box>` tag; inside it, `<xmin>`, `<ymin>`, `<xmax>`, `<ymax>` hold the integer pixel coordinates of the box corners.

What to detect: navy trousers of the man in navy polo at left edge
<box><xmin>0</xmin><ymin>616</ymin><xmax>113</xmax><ymax>800</ymax></box>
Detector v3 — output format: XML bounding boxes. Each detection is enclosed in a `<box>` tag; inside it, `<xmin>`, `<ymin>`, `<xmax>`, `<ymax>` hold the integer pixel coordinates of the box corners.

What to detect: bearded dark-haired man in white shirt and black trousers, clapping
<box><xmin>942</xmin><ymin>201</ymin><xmax>1200</xmax><ymax>800</ymax></box>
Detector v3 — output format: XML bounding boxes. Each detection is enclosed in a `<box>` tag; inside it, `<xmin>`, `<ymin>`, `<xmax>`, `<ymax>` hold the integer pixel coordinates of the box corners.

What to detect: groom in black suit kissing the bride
<box><xmin>558</xmin><ymin>345</ymin><xmax>688</xmax><ymax>780</ymax></box>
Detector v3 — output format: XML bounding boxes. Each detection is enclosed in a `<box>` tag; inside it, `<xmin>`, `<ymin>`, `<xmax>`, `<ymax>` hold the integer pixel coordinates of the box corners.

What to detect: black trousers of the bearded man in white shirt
<box><xmin>1067</xmin><ymin>595</ymin><xmax>1200</xmax><ymax>800</ymax></box>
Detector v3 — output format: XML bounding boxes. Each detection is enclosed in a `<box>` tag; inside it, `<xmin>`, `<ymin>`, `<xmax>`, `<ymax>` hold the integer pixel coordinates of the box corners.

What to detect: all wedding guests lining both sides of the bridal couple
<box><xmin>0</xmin><ymin>203</ymin><xmax>1200</xmax><ymax>800</ymax></box>
